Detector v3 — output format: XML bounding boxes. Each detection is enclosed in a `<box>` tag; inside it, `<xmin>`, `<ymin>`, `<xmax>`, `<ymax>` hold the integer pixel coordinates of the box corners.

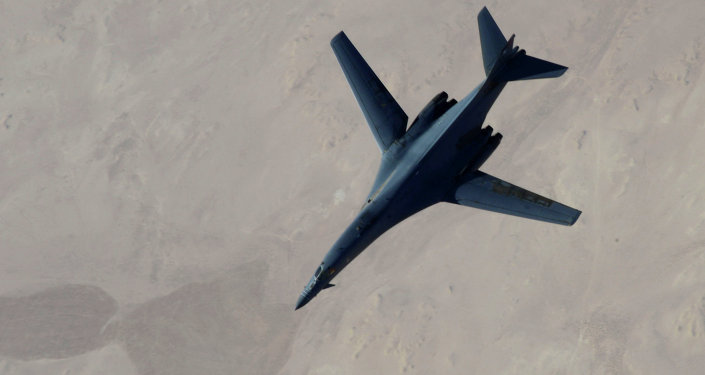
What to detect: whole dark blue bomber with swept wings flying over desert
<box><xmin>295</xmin><ymin>8</ymin><xmax>581</xmax><ymax>310</ymax></box>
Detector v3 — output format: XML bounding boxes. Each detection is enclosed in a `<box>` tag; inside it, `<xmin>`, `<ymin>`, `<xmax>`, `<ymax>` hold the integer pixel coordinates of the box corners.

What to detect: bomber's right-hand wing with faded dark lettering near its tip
<box><xmin>447</xmin><ymin>171</ymin><xmax>581</xmax><ymax>225</ymax></box>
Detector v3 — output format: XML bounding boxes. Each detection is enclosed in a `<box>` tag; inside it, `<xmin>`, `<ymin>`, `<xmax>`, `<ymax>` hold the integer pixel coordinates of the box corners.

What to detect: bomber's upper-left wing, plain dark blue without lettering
<box><xmin>330</xmin><ymin>31</ymin><xmax>409</xmax><ymax>152</ymax></box>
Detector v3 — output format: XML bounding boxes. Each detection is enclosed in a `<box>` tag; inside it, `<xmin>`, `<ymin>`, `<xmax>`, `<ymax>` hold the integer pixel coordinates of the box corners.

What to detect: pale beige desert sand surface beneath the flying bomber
<box><xmin>0</xmin><ymin>0</ymin><xmax>705</xmax><ymax>375</ymax></box>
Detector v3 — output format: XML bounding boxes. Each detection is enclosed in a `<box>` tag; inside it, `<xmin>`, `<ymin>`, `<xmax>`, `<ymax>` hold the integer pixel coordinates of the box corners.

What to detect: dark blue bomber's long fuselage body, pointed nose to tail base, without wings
<box><xmin>296</xmin><ymin>77</ymin><xmax>506</xmax><ymax>309</ymax></box>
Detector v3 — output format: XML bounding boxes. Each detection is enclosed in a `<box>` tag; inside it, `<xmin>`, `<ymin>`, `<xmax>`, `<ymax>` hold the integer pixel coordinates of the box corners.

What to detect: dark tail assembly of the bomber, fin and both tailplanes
<box><xmin>477</xmin><ymin>7</ymin><xmax>568</xmax><ymax>82</ymax></box>
